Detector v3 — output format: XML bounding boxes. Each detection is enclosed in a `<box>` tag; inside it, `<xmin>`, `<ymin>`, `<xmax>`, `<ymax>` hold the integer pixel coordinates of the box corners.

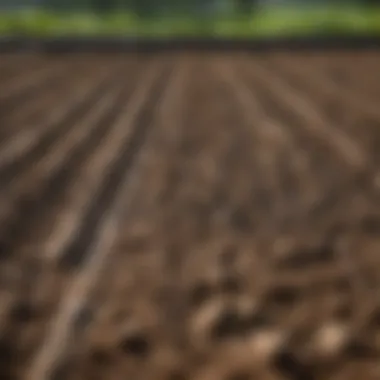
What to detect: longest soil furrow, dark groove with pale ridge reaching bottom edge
<box><xmin>29</xmin><ymin>58</ymin><xmax>170</xmax><ymax>380</ymax></box>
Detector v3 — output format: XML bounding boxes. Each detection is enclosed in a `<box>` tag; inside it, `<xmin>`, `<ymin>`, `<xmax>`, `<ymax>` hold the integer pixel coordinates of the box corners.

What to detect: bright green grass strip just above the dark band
<box><xmin>0</xmin><ymin>7</ymin><xmax>380</xmax><ymax>37</ymax></box>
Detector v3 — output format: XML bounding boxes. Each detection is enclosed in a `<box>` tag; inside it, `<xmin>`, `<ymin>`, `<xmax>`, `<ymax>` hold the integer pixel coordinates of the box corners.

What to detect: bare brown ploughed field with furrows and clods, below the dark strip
<box><xmin>0</xmin><ymin>52</ymin><xmax>380</xmax><ymax>380</ymax></box>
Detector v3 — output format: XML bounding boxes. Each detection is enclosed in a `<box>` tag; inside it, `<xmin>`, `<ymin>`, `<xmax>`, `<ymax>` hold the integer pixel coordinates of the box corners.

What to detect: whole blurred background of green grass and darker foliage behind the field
<box><xmin>0</xmin><ymin>0</ymin><xmax>380</xmax><ymax>37</ymax></box>
